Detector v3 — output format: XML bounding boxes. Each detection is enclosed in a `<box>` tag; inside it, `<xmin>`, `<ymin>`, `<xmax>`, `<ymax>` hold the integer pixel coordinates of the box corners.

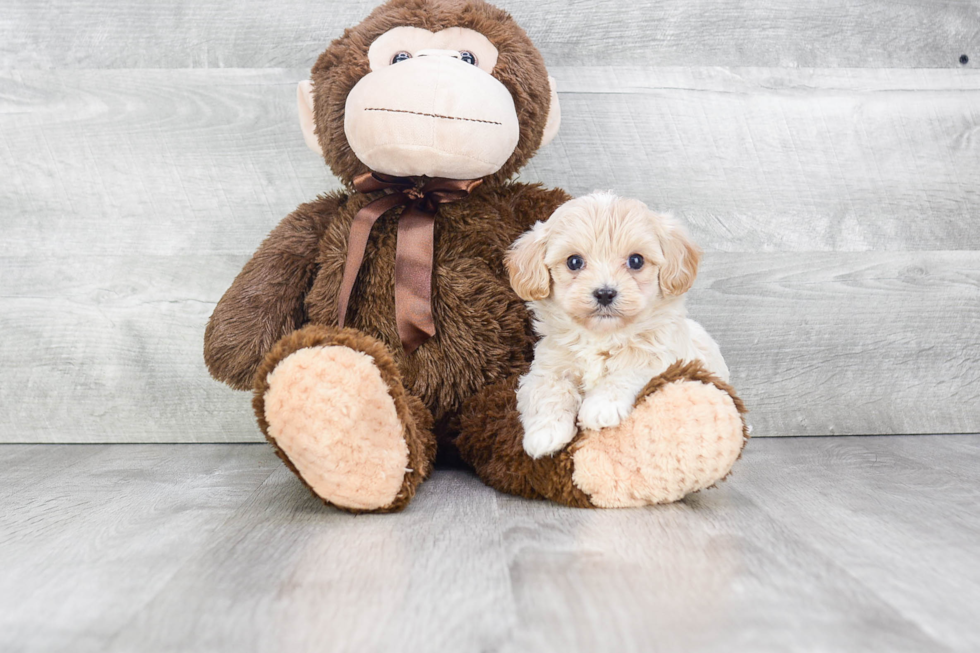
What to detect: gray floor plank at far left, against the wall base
<box><xmin>0</xmin><ymin>445</ymin><xmax>278</xmax><ymax>651</ymax></box>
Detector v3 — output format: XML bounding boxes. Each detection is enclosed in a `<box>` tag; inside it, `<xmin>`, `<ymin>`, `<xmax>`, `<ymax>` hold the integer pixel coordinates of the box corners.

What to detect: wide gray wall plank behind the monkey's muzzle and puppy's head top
<box><xmin>0</xmin><ymin>68</ymin><xmax>980</xmax><ymax>255</ymax></box>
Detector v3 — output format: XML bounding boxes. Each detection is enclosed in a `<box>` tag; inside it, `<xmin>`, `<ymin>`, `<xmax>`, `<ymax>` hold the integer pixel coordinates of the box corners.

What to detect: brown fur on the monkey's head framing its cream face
<box><xmin>312</xmin><ymin>0</ymin><xmax>551</xmax><ymax>185</ymax></box>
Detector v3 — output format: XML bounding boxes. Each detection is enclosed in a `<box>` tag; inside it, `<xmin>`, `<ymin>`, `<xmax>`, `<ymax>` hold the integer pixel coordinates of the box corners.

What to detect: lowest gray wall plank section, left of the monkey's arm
<box><xmin>0</xmin><ymin>255</ymin><xmax>262</xmax><ymax>442</ymax></box>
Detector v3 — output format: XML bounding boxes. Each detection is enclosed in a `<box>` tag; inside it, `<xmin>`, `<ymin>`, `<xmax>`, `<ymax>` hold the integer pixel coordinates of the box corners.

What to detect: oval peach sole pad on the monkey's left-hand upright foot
<box><xmin>265</xmin><ymin>347</ymin><xmax>408</xmax><ymax>510</ymax></box>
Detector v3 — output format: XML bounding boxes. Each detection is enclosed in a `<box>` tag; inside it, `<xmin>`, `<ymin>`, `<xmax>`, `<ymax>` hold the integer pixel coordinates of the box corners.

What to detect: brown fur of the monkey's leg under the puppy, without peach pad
<box><xmin>456</xmin><ymin>362</ymin><xmax>748</xmax><ymax>508</ymax></box>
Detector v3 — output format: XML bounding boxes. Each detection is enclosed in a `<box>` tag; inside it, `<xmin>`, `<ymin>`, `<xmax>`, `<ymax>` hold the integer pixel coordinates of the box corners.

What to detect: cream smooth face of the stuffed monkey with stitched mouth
<box><xmin>344</xmin><ymin>27</ymin><xmax>520</xmax><ymax>179</ymax></box>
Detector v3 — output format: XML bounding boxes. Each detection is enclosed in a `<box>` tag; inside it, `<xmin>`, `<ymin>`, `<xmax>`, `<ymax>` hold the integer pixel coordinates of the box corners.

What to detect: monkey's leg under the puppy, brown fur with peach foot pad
<box><xmin>456</xmin><ymin>363</ymin><xmax>746</xmax><ymax>508</ymax></box>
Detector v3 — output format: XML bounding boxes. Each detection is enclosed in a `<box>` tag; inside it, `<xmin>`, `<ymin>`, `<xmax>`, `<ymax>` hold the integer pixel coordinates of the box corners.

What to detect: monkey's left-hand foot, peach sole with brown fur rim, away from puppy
<box><xmin>252</xmin><ymin>325</ymin><xmax>436</xmax><ymax>512</ymax></box>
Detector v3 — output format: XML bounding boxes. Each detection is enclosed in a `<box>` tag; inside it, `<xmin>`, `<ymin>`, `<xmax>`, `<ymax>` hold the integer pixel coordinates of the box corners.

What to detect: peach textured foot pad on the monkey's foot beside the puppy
<box><xmin>572</xmin><ymin>381</ymin><xmax>743</xmax><ymax>508</ymax></box>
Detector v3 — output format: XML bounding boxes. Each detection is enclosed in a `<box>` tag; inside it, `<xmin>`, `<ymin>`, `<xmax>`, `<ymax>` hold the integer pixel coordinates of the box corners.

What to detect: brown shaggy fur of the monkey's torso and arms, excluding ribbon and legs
<box><xmin>205</xmin><ymin>184</ymin><xmax>568</xmax><ymax>429</ymax></box>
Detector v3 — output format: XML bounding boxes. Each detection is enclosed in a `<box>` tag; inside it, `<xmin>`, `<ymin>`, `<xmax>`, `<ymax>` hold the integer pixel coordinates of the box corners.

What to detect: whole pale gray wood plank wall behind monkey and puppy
<box><xmin>0</xmin><ymin>0</ymin><xmax>980</xmax><ymax>442</ymax></box>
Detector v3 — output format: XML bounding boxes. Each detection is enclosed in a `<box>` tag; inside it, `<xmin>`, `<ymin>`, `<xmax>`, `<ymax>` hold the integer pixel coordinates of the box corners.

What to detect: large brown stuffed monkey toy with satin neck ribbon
<box><xmin>204</xmin><ymin>0</ymin><xmax>744</xmax><ymax>512</ymax></box>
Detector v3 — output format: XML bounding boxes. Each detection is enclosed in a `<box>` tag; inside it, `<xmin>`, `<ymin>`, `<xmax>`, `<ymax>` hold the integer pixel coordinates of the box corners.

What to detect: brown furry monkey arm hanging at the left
<box><xmin>204</xmin><ymin>194</ymin><xmax>347</xmax><ymax>390</ymax></box>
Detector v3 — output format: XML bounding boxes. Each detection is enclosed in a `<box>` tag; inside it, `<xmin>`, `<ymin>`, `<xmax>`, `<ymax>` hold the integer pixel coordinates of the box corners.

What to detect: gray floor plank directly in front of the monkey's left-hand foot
<box><xmin>106</xmin><ymin>469</ymin><xmax>517</xmax><ymax>652</ymax></box>
